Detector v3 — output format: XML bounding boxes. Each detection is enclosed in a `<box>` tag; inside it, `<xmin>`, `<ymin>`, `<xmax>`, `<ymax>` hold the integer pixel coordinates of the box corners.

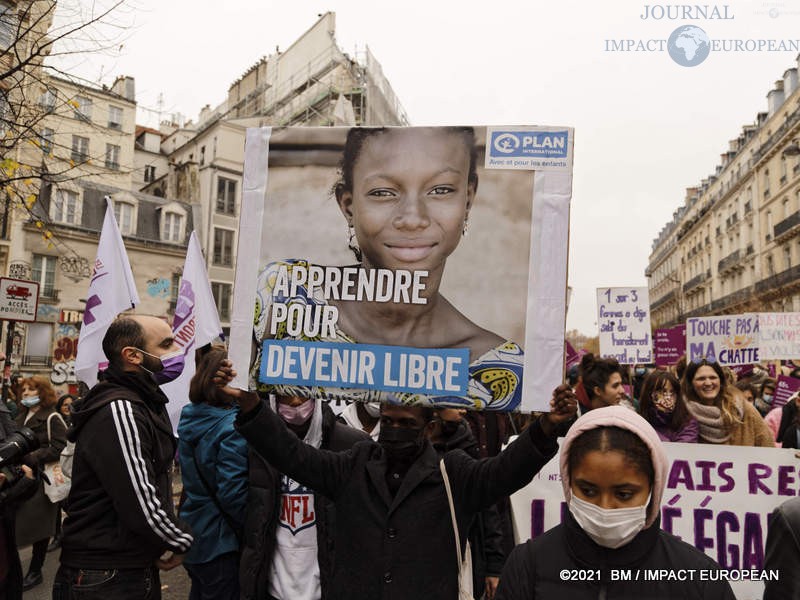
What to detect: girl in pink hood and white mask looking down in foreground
<box><xmin>496</xmin><ymin>406</ymin><xmax>735</xmax><ymax>600</ymax></box>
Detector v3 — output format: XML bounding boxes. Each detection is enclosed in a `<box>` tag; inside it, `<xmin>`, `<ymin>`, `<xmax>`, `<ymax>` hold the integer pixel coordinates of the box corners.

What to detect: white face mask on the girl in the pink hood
<box><xmin>569</xmin><ymin>493</ymin><xmax>652</xmax><ymax>548</ymax></box>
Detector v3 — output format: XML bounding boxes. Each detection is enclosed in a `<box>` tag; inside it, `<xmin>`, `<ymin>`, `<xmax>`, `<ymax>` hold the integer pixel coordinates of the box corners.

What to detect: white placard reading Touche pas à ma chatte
<box><xmin>686</xmin><ymin>313</ymin><xmax>760</xmax><ymax>366</ymax></box>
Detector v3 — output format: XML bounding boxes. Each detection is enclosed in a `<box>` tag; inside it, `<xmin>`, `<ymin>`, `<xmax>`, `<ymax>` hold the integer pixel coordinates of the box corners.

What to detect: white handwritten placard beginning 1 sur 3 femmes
<box><xmin>597</xmin><ymin>287</ymin><xmax>653</xmax><ymax>365</ymax></box>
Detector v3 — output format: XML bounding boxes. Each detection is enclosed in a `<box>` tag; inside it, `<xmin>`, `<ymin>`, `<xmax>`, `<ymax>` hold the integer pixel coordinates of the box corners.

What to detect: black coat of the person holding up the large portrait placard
<box><xmin>237</xmin><ymin>403</ymin><xmax>557</xmax><ymax>600</ymax></box>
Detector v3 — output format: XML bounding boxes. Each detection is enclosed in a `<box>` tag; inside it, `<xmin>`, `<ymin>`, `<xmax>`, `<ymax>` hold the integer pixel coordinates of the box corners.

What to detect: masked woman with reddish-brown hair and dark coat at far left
<box><xmin>17</xmin><ymin>375</ymin><xmax>67</xmax><ymax>590</ymax></box>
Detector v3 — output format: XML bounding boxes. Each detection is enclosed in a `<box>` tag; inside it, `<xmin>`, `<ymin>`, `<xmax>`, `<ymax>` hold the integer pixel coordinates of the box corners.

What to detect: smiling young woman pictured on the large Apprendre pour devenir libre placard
<box><xmin>255</xmin><ymin>127</ymin><xmax>523</xmax><ymax>411</ymax></box>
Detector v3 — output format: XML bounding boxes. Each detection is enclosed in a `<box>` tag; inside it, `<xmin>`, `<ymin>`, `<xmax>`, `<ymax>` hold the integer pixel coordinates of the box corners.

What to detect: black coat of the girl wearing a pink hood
<box><xmin>496</xmin><ymin>512</ymin><xmax>736</xmax><ymax>600</ymax></box>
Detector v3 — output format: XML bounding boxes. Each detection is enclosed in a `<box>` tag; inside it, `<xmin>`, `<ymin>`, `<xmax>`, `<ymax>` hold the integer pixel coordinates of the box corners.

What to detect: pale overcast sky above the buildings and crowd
<box><xmin>59</xmin><ymin>0</ymin><xmax>800</xmax><ymax>335</ymax></box>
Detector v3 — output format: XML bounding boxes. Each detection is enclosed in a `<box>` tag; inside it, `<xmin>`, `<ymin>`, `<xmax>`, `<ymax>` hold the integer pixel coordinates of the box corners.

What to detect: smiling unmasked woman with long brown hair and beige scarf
<box><xmin>681</xmin><ymin>359</ymin><xmax>775</xmax><ymax>448</ymax></box>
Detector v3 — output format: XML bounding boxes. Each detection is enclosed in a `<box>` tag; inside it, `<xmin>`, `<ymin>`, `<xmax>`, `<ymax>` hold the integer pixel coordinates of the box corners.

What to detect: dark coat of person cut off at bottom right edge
<box><xmin>764</xmin><ymin>498</ymin><xmax>800</xmax><ymax>600</ymax></box>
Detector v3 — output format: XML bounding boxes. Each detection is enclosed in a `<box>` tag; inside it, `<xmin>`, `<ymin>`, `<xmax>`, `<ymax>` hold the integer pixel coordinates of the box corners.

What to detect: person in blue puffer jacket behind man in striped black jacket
<box><xmin>178</xmin><ymin>347</ymin><xmax>247</xmax><ymax>600</ymax></box>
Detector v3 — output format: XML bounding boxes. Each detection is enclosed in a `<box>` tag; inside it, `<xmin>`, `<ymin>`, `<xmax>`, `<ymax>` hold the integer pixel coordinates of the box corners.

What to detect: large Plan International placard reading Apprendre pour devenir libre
<box><xmin>231</xmin><ymin>127</ymin><xmax>573</xmax><ymax>410</ymax></box>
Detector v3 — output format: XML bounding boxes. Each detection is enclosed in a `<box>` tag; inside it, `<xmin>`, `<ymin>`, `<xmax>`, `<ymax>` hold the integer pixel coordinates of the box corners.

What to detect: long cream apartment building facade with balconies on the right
<box><xmin>645</xmin><ymin>56</ymin><xmax>800</xmax><ymax>327</ymax></box>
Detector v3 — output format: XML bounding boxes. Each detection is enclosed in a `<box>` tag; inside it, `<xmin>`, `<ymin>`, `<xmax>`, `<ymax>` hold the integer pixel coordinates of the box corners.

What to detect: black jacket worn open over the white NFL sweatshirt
<box><xmin>239</xmin><ymin>403</ymin><xmax>369</xmax><ymax>600</ymax></box>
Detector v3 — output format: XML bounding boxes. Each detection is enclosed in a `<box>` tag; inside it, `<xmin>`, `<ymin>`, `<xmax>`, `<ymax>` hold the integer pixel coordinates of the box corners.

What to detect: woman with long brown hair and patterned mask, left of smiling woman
<box><xmin>638</xmin><ymin>370</ymin><xmax>698</xmax><ymax>443</ymax></box>
